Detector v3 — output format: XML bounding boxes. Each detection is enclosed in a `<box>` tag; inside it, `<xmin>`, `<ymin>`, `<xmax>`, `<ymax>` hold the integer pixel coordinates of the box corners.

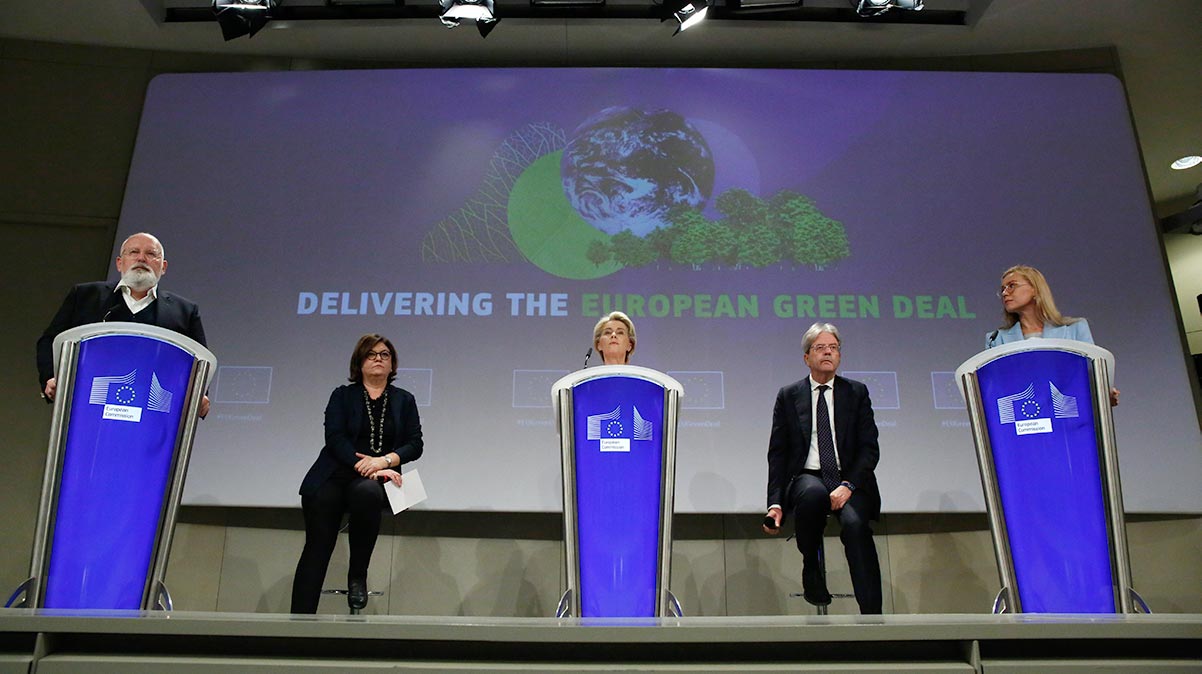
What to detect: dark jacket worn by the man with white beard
<box><xmin>37</xmin><ymin>281</ymin><xmax>208</xmax><ymax>389</ymax></box>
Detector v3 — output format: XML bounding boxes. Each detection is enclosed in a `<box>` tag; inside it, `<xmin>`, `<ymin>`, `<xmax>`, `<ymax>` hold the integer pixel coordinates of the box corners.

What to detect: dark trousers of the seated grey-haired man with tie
<box><xmin>789</xmin><ymin>473</ymin><xmax>882</xmax><ymax>615</ymax></box>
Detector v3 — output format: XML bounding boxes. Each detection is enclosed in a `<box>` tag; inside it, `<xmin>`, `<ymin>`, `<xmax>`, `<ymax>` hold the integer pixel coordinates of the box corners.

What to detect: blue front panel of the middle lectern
<box><xmin>572</xmin><ymin>377</ymin><xmax>665</xmax><ymax>618</ymax></box>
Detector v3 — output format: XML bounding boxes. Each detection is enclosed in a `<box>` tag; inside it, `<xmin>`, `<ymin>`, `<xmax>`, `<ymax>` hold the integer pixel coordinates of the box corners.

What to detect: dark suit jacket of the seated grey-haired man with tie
<box><xmin>768</xmin><ymin>375</ymin><xmax>881</xmax><ymax>519</ymax></box>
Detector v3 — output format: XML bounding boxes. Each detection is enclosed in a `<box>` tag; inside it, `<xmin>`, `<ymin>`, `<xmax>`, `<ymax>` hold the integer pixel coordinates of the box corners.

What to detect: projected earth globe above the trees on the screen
<box><xmin>560</xmin><ymin>107</ymin><xmax>714</xmax><ymax>237</ymax></box>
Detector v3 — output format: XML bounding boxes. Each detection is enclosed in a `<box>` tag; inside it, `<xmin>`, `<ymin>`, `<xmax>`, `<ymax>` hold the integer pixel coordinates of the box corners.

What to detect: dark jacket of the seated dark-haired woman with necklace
<box><xmin>301</xmin><ymin>383</ymin><xmax>424</xmax><ymax>496</ymax></box>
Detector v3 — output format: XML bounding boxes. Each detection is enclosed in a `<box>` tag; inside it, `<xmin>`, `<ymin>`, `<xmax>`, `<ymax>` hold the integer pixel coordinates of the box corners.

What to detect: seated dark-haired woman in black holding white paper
<box><xmin>292</xmin><ymin>334</ymin><xmax>422</xmax><ymax>613</ymax></box>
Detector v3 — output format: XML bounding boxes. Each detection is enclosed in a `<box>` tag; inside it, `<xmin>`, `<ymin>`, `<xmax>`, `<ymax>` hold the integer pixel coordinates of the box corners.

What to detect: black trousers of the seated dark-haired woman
<box><xmin>292</xmin><ymin>473</ymin><xmax>388</xmax><ymax>613</ymax></box>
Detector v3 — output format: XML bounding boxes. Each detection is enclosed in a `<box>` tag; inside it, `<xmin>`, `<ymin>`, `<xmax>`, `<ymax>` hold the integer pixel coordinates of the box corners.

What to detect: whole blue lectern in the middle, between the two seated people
<box><xmin>552</xmin><ymin>365</ymin><xmax>684</xmax><ymax>618</ymax></box>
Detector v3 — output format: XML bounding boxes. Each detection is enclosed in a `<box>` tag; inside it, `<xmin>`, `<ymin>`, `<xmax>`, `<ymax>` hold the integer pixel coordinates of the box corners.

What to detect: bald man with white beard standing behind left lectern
<box><xmin>37</xmin><ymin>232</ymin><xmax>209</xmax><ymax>417</ymax></box>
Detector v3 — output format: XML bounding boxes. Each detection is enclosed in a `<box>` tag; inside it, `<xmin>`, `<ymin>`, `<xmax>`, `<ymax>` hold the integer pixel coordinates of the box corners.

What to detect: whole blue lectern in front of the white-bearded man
<box><xmin>10</xmin><ymin>323</ymin><xmax>216</xmax><ymax>609</ymax></box>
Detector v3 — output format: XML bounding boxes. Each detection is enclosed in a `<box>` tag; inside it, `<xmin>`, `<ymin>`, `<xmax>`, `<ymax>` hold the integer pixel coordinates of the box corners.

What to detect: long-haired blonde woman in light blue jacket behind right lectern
<box><xmin>984</xmin><ymin>264</ymin><xmax>1119</xmax><ymax>405</ymax></box>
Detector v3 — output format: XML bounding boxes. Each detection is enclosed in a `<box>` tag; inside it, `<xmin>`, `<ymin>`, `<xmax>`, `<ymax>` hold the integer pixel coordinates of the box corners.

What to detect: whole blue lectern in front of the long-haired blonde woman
<box><xmin>956</xmin><ymin>339</ymin><xmax>1147</xmax><ymax>613</ymax></box>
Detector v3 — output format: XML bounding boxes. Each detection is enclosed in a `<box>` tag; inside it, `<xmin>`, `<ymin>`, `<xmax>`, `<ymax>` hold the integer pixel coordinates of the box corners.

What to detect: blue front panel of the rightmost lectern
<box><xmin>977</xmin><ymin>351</ymin><xmax>1115</xmax><ymax>613</ymax></box>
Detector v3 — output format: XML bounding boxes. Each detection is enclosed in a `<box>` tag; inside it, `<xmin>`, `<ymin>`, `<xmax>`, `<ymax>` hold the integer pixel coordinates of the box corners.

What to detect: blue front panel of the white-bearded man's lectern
<box><xmin>43</xmin><ymin>334</ymin><xmax>196</xmax><ymax>609</ymax></box>
